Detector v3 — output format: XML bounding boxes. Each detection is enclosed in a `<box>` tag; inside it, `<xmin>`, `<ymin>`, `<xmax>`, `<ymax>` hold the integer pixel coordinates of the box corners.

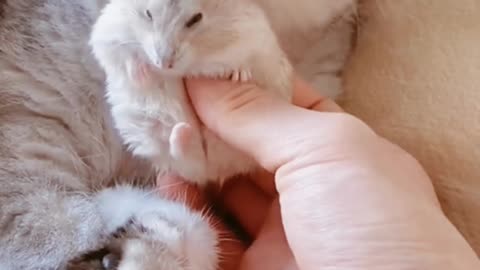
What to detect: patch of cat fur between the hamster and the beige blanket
<box><xmin>254</xmin><ymin>0</ymin><xmax>357</xmax><ymax>99</ymax></box>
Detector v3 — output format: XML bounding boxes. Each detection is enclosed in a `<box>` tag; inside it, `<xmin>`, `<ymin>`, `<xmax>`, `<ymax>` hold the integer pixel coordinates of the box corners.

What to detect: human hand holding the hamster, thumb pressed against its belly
<box><xmin>162</xmin><ymin>76</ymin><xmax>480</xmax><ymax>270</ymax></box>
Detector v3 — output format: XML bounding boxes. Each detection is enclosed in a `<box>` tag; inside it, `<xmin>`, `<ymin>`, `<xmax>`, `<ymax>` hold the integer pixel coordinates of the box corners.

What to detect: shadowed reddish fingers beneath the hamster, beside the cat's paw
<box><xmin>157</xmin><ymin>172</ymin><xmax>298</xmax><ymax>270</ymax></box>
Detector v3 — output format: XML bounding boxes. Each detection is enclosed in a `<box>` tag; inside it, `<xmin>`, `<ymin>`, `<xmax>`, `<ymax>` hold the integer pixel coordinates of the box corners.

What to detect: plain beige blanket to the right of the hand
<box><xmin>342</xmin><ymin>0</ymin><xmax>480</xmax><ymax>254</ymax></box>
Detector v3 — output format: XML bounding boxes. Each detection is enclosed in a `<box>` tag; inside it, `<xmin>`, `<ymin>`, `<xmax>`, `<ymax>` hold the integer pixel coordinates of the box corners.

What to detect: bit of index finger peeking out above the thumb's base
<box><xmin>293</xmin><ymin>76</ymin><xmax>343</xmax><ymax>112</ymax></box>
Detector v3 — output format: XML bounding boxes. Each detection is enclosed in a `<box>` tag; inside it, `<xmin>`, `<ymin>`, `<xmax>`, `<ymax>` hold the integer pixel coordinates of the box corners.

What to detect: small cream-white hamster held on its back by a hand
<box><xmin>89</xmin><ymin>0</ymin><xmax>293</xmax><ymax>184</ymax></box>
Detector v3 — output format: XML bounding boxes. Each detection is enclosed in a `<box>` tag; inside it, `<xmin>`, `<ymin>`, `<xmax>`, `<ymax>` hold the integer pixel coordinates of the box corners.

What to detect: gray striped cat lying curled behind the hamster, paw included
<box><xmin>0</xmin><ymin>0</ymin><xmax>353</xmax><ymax>270</ymax></box>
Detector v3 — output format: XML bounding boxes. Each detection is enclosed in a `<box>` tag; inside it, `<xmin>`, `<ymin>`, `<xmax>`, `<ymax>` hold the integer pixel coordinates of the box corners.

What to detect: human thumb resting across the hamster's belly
<box><xmin>186</xmin><ymin>79</ymin><xmax>344</xmax><ymax>171</ymax></box>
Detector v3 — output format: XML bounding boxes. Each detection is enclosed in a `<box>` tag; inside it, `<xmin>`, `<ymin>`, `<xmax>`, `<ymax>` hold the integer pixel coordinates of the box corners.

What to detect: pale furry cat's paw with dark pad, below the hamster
<box><xmin>102</xmin><ymin>209</ymin><xmax>217</xmax><ymax>270</ymax></box>
